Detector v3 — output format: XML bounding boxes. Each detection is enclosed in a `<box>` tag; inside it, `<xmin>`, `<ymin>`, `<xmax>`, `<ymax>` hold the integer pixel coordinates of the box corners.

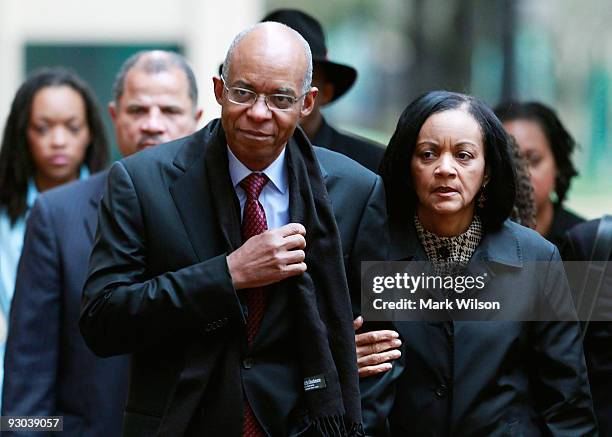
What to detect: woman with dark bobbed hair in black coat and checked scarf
<box><xmin>368</xmin><ymin>91</ymin><xmax>597</xmax><ymax>436</ymax></box>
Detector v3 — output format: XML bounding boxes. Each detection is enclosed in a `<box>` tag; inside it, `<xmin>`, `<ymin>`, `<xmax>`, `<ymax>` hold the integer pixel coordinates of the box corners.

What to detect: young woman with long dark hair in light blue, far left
<box><xmin>0</xmin><ymin>68</ymin><xmax>108</xmax><ymax>406</ymax></box>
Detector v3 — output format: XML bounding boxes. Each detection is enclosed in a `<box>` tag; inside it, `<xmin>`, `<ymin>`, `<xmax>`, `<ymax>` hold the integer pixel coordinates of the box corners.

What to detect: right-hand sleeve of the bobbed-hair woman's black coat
<box><xmin>531</xmin><ymin>248</ymin><xmax>597</xmax><ymax>436</ymax></box>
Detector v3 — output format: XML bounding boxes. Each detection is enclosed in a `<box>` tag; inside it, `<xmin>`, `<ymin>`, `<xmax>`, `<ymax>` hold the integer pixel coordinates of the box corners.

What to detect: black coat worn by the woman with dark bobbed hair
<box><xmin>389</xmin><ymin>221</ymin><xmax>596</xmax><ymax>437</ymax></box>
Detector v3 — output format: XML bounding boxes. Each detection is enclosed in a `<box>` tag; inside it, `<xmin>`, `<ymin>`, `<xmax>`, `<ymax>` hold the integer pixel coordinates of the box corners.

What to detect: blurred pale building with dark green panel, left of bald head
<box><xmin>0</xmin><ymin>0</ymin><xmax>263</xmax><ymax>156</ymax></box>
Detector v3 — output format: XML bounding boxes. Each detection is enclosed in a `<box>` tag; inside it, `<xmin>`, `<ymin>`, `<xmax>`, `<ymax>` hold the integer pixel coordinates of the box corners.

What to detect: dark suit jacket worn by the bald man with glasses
<box><xmin>81</xmin><ymin>122</ymin><xmax>386</xmax><ymax>436</ymax></box>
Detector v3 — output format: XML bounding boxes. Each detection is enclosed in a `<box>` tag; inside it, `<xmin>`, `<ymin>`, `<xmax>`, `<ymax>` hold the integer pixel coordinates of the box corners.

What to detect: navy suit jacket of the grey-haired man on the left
<box><xmin>2</xmin><ymin>173</ymin><xmax>128</xmax><ymax>437</ymax></box>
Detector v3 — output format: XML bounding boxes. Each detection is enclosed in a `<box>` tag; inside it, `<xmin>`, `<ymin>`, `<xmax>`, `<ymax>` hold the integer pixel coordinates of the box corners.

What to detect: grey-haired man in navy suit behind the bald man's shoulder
<box><xmin>2</xmin><ymin>51</ymin><xmax>202</xmax><ymax>437</ymax></box>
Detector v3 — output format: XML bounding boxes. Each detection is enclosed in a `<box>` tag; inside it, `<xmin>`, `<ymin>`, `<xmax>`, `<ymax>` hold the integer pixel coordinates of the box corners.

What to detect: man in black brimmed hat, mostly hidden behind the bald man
<box><xmin>261</xmin><ymin>9</ymin><xmax>384</xmax><ymax>172</ymax></box>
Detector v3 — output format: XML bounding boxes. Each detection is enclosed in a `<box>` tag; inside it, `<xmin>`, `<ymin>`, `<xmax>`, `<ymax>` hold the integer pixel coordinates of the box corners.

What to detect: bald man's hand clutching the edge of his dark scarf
<box><xmin>227</xmin><ymin>223</ymin><xmax>306</xmax><ymax>290</ymax></box>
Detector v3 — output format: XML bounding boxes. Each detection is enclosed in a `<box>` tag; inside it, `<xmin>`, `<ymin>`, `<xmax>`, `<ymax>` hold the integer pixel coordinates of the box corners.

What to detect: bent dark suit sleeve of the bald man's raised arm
<box><xmin>80</xmin><ymin>162</ymin><xmax>244</xmax><ymax>356</ymax></box>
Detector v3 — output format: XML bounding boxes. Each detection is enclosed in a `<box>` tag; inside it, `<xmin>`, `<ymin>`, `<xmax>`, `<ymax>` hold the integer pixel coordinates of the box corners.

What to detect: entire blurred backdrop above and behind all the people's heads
<box><xmin>0</xmin><ymin>0</ymin><xmax>612</xmax><ymax>216</ymax></box>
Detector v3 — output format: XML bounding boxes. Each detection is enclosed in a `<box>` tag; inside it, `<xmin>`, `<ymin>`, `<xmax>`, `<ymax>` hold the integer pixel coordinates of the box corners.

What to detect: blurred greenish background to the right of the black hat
<box><xmin>266</xmin><ymin>0</ymin><xmax>612</xmax><ymax>217</ymax></box>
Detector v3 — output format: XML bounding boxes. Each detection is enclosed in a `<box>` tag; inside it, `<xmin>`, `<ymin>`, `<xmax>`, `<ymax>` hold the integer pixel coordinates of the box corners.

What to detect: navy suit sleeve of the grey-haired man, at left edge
<box><xmin>2</xmin><ymin>198</ymin><xmax>62</xmax><ymax>435</ymax></box>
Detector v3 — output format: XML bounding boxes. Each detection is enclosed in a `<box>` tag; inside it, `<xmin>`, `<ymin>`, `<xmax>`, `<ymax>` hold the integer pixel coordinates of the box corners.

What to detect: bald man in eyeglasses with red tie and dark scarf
<box><xmin>80</xmin><ymin>23</ymin><xmax>386</xmax><ymax>437</ymax></box>
